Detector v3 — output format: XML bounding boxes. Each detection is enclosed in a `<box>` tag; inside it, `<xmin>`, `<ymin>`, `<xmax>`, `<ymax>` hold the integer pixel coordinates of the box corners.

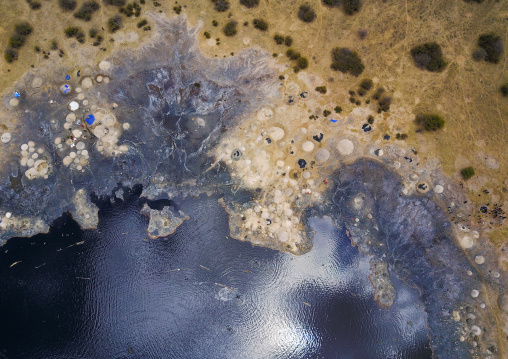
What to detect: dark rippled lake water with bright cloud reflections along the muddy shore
<box><xmin>0</xmin><ymin>197</ymin><xmax>430</xmax><ymax>359</ymax></box>
